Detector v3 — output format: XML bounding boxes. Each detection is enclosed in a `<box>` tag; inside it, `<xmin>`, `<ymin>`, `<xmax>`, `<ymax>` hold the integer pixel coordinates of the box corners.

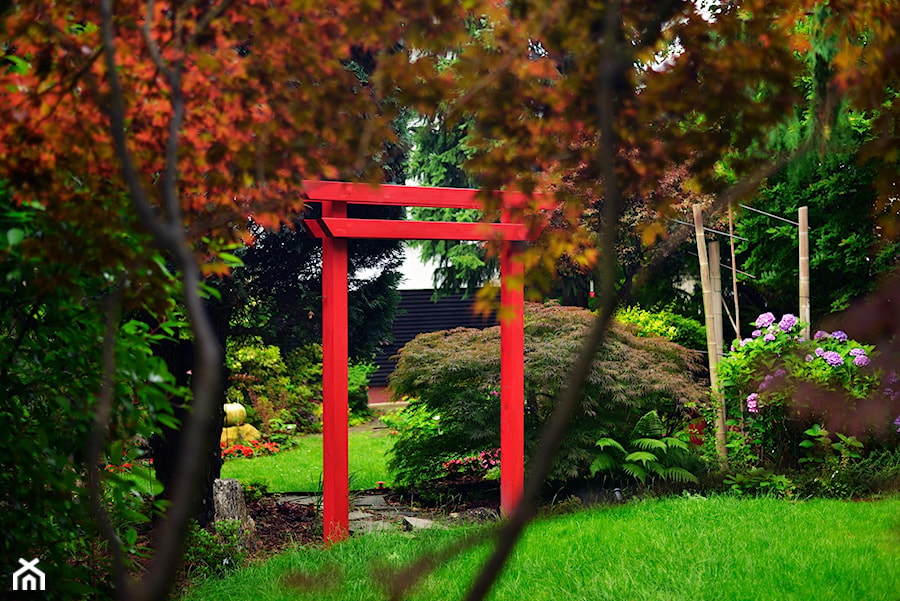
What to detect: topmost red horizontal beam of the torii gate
<box><xmin>303</xmin><ymin>180</ymin><xmax>556</xmax><ymax>209</ymax></box>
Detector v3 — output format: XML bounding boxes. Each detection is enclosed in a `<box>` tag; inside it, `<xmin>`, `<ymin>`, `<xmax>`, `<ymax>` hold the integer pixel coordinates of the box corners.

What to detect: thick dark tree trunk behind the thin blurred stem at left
<box><xmin>150</xmin><ymin>303</ymin><xmax>229</xmax><ymax>526</ymax></box>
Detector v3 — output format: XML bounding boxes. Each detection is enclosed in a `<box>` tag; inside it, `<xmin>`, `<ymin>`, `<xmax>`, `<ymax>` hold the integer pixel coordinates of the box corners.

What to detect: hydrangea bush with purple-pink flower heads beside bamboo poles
<box><xmin>719</xmin><ymin>313</ymin><xmax>900</xmax><ymax>468</ymax></box>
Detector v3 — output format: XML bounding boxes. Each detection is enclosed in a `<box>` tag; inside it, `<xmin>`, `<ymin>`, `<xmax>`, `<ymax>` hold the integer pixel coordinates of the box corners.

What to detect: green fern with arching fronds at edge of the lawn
<box><xmin>591</xmin><ymin>410</ymin><xmax>697</xmax><ymax>484</ymax></box>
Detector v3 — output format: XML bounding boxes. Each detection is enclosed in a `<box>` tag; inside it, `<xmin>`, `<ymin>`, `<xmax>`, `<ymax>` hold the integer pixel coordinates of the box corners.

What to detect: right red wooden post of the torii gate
<box><xmin>500</xmin><ymin>240</ymin><xmax>525</xmax><ymax>516</ymax></box>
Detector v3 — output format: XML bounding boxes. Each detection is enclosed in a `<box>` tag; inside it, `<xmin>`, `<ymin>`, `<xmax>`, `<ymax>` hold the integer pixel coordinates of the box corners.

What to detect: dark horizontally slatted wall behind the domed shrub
<box><xmin>369</xmin><ymin>290</ymin><xmax>498</xmax><ymax>386</ymax></box>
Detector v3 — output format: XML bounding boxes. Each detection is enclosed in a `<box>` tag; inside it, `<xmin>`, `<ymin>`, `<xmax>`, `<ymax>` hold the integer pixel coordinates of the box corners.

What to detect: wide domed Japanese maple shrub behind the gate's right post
<box><xmin>389</xmin><ymin>305</ymin><xmax>704</xmax><ymax>484</ymax></box>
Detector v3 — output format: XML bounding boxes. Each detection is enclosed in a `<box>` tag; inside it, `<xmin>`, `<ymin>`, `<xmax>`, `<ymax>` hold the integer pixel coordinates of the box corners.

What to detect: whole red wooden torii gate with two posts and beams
<box><xmin>304</xmin><ymin>181</ymin><xmax>549</xmax><ymax>542</ymax></box>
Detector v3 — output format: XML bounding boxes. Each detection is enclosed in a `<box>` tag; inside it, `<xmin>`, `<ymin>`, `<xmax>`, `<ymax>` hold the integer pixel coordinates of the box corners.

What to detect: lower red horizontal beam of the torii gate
<box><xmin>304</xmin><ymin>217</ymin><xmax>533</xmax><ymax>240</ymax></box>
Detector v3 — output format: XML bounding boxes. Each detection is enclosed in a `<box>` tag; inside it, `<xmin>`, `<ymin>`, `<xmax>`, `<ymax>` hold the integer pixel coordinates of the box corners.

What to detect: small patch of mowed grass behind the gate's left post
<box><xmin>222</xmin><ymin>430</ymin><xmax>392</xmax><ymax>492</ymax></box>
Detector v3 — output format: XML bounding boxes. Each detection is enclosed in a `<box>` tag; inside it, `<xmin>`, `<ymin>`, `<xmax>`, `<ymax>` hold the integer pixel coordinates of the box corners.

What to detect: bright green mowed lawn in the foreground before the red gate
<box><xmin>185</xmin><ymin>497</ymin><xmax>900</xmax><ymax>601</ymax></box>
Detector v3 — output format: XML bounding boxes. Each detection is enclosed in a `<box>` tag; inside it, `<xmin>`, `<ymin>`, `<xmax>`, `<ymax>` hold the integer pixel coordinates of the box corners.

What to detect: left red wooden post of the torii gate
<box><xmin>322</xmin><ymin>201</ymin><xmax>350</xmax><ymax>543</ymax></box>
